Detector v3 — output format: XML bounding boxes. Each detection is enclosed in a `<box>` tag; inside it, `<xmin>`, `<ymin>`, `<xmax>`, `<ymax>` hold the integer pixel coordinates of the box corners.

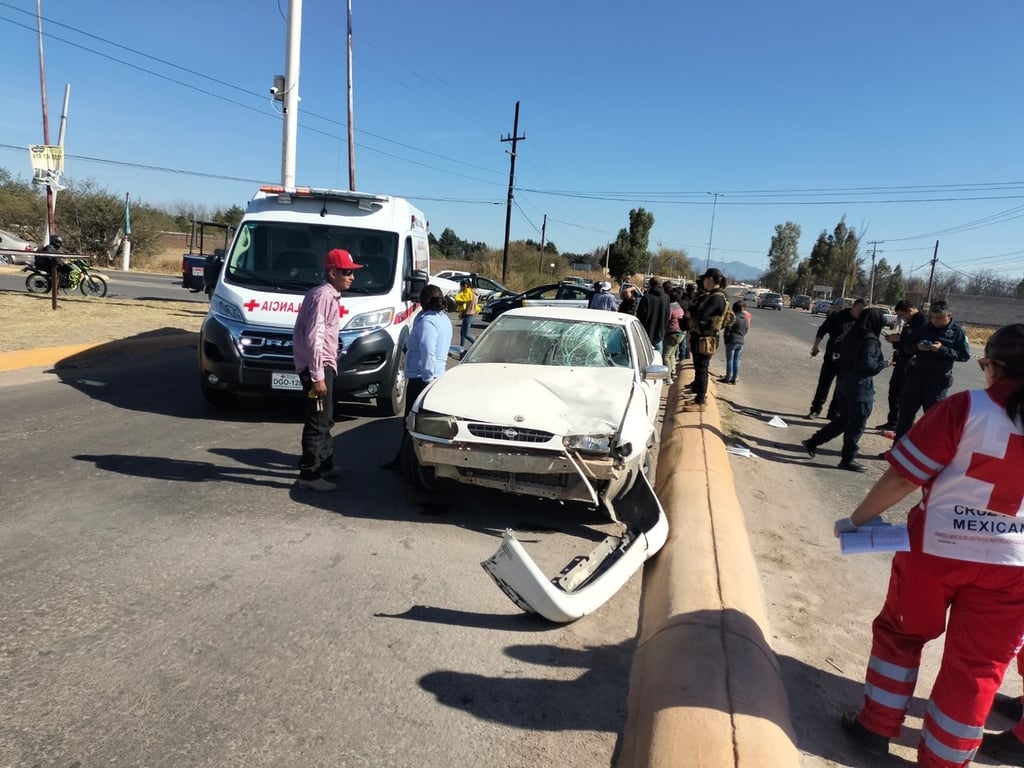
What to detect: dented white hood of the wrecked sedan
<box><xmin>420</xmin><ymin>362</ymin><xmax>633</xmax><ymax>435</ymax></box>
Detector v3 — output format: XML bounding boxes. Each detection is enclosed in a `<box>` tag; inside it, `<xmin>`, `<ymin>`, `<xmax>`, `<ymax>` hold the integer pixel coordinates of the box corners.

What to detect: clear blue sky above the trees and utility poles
<box><xmin>0</xmin><ymin>0</ymin><xmax>1024</xmax><ymax>279</ymax></box>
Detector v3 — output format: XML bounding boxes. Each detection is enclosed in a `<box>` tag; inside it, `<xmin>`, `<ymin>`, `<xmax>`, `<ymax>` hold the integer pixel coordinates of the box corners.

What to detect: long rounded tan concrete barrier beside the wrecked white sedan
<box><xmin>617</xmin><ymin>368</ymin><xmax>800</xmax><ymax>768</ymax></box>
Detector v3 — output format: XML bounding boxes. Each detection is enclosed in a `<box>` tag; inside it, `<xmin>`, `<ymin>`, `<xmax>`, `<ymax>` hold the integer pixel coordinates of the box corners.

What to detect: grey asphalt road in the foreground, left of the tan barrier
<box><xmin>0</xmin><ymin>348</ymin><xmax>639</xmax><ymax>768</ymax></box>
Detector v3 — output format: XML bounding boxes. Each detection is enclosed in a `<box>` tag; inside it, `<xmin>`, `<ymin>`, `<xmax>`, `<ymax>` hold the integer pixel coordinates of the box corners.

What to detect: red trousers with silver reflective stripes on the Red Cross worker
<box><xmin>858</xmin><ymin>552</ymin><xmax>1024</xmax><ymax>768</ymax></box>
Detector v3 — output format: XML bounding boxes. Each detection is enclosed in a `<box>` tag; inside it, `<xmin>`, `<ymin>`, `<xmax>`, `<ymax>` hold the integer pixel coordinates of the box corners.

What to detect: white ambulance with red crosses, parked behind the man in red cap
<box><xmin>199</xmin><ymin>186</ymin><xmax>430</xmax><ymax>416</ymax></box>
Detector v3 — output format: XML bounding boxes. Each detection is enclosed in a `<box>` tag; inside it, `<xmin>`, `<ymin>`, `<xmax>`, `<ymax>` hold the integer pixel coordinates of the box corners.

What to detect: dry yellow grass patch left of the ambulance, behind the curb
<box><xmin>0</xmin><ymin>291</ymin><xmax>207</xmax><ymax>352</ymax></box>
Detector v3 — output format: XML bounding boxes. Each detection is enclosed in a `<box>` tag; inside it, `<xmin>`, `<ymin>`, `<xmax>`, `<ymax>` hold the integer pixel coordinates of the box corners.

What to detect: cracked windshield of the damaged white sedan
<box><xmin>463</xmin><ymin>314</ymin><xmax>632</xmax><ymax>368</ymax></box>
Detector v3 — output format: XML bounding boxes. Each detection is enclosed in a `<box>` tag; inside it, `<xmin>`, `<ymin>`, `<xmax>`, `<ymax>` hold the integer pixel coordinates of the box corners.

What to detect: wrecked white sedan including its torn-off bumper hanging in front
<box><xmin>404</xmin><ymin>307</ymin><xmax>668</xmax><ymax>622</ymax></box>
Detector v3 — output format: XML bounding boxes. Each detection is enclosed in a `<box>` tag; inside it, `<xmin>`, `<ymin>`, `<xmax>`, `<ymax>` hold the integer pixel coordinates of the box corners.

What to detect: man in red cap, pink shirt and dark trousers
<box><xmin>292</xmin><ymin>248</ymin><xmax>362</xmax><ymax>490</ymax></box>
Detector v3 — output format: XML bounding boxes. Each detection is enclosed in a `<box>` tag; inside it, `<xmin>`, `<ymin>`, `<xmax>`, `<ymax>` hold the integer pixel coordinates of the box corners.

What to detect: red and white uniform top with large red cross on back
<box><xmin>889</xmin><ymin>385</ymin><xmax>1024</xmax><ymax>565</ymax></box>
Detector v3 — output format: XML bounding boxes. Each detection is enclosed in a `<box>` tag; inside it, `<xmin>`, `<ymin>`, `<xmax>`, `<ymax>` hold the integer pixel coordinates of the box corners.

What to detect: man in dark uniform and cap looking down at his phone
<box><xmin>896</xmin><ymin>301</ymin><xmax>971</xmax><ymax>440</ymax></box>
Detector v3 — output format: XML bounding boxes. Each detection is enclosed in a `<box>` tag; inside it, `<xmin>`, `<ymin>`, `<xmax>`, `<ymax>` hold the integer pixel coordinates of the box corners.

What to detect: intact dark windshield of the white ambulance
<box><xmin>225</xmin><ymin>221</ymin><xmax>398</xmax><ymax>295</ymax></box>
